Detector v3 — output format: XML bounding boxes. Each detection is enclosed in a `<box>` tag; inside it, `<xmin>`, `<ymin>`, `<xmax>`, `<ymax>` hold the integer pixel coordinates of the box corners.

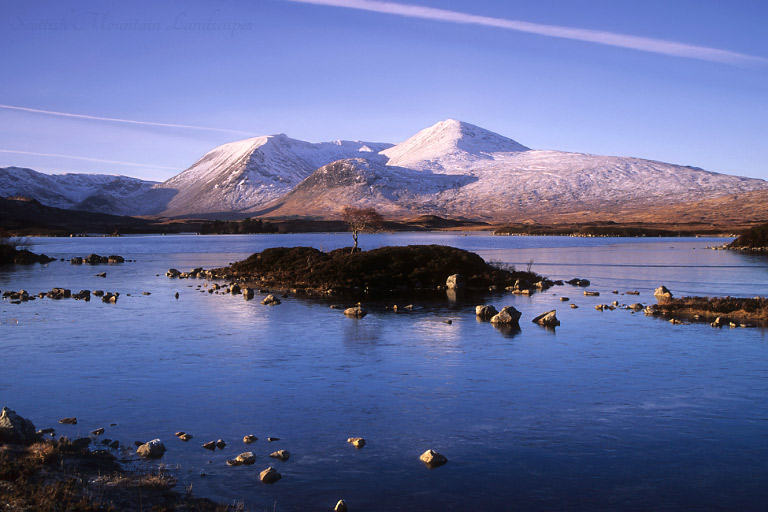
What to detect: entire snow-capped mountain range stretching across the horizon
<box><xmin>6</xmin><ymin>119</ymin><xmax>768</xmax><ymax>221</ymax></box>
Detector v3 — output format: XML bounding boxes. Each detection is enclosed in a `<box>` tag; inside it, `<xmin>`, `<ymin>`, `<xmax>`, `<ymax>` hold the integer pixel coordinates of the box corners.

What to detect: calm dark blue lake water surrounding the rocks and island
<box><xmin>0</xmin><ymin>233</ymin><xmax>768</xmax><ymax>511</ymax></box>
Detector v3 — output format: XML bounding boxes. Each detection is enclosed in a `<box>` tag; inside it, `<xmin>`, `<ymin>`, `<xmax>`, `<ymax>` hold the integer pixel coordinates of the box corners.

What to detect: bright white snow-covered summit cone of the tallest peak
<box><xmin>381</xmin><ymin>119</ymin><xmax>528</xmax><ymax>173</ymax></box>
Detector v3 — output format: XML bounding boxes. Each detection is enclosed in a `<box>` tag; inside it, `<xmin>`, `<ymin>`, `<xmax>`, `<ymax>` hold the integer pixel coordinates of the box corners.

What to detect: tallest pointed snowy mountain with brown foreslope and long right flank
<box><xmin>256</xmin><ymin>120</ymin><xmax>768</xmax><ymax>220</ymax></box>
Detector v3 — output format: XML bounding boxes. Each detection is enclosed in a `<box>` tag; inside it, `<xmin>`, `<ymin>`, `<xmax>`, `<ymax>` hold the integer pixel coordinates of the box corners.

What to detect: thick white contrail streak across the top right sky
<box><xmin>288</xmin><ymin>0</ymin><xmax>768</xmax><ymax>64</ymax></box>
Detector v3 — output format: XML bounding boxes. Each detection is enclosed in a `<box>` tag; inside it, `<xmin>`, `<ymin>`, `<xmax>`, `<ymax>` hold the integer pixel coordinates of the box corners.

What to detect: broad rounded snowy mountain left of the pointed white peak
<box><xmin>152</xmin><ymin>134</ymin><xmax>391</xmax><ymax>216</ymax></box>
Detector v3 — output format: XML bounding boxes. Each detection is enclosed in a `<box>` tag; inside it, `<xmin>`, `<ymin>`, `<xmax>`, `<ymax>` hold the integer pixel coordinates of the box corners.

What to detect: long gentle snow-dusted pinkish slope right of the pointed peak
<box><xmin>428</xmin><ymin>151</ymin><xmax>768</xmax><ymax>218</ymax></box>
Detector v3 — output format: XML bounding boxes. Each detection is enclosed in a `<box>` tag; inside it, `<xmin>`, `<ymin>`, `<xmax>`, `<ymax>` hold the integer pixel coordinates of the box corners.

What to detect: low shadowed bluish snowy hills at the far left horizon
<box><xmin>0</xmin><ymin>167</ymin><xmax>157</xmax><ymax>215</ymax></box>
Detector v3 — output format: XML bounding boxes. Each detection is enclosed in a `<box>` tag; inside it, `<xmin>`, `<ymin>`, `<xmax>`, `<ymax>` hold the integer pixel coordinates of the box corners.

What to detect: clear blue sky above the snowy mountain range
<box><xmin>0</xmin><ymin>0</ymin><xmax>768</xmax><ymax>180</ymax></box>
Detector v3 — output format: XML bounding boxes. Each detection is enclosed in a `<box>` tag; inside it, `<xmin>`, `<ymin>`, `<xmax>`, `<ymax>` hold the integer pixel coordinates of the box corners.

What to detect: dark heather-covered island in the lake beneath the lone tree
<box><xmin>204</xmin><ymin>245</ymin><xmax>547</xmax><ymax>295</ymax></box>
